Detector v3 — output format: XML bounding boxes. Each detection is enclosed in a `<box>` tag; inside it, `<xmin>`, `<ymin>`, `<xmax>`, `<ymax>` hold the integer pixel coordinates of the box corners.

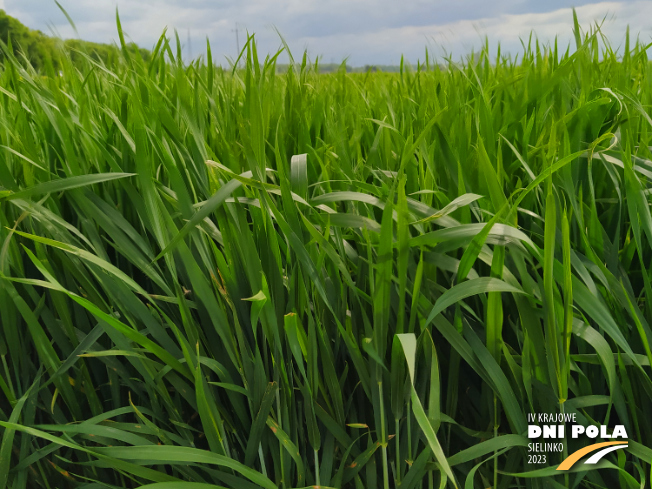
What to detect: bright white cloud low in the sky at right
<box><xmin>288</xmin><ymin>1</ymin><xmax>652</xmax><ymax>64</ymax></box>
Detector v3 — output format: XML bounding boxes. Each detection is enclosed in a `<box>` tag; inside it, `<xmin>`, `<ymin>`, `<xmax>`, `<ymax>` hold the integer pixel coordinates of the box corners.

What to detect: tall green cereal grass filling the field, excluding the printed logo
<box><xmin>0</xmin><ymin>13</ymin><xmax>652</xmax><ymax>489</ymax></box>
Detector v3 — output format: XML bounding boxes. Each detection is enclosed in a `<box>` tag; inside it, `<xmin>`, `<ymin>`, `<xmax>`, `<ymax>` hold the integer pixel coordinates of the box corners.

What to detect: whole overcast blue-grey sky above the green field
<box><xmin>0</xmin><ymin>0</ymin><xmax>652</xmax><ymax>66</ymax></box>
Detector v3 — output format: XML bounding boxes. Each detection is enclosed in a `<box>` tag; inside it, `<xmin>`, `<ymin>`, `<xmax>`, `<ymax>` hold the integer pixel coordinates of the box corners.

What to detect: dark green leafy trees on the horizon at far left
<box><xmin>0</xmin><ymin>10</ymin><xmax>149</xmax><ymax>74</ymax></box>
